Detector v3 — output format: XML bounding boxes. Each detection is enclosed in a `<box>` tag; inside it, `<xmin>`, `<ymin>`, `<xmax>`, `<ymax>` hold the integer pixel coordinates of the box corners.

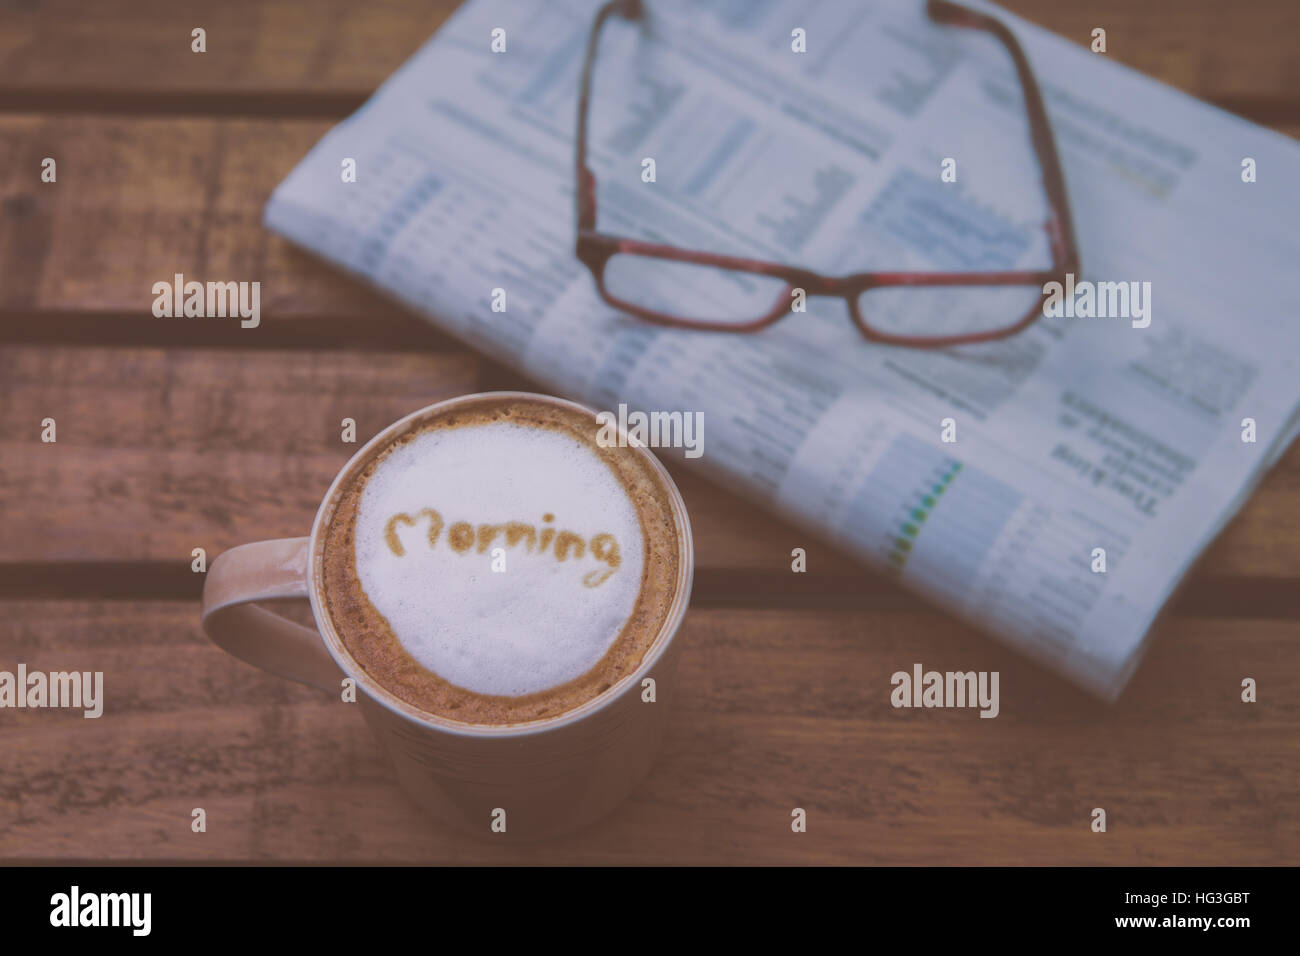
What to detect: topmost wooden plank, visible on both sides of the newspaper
<box><xmin>0</xmin><ymin>0</ymin><xmax>1300</xmax><ymax>109</ymax></box>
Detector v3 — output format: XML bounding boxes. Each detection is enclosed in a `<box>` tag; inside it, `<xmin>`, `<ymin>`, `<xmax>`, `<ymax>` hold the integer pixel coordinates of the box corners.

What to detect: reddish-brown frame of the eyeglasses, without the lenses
<box><xmin>575</xmin><ymin>0</ymin><xmax>1079</xmax><ymax>349</ymax></box>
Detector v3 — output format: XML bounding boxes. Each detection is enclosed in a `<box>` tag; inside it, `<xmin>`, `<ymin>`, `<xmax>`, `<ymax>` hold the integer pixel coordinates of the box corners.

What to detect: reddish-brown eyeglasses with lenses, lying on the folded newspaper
<box><xmin>575</xmin><ymin>0</ymin><xmax>1079</xmax><ymax>349</ymax></box>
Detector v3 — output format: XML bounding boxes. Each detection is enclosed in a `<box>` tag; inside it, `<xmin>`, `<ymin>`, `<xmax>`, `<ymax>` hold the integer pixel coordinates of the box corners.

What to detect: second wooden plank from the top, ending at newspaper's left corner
<box><xmin>0</xmin><ymin>116</ymin><xmax>1300</xmax><ymax>329</ymax></box>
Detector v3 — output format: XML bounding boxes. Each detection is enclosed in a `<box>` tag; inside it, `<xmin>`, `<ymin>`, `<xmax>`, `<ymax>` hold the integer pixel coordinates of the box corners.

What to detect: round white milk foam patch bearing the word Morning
<box><xmin>355</xmin><ymin>421</ymin><xmax>645</xmax><ymax>696</ymax></box>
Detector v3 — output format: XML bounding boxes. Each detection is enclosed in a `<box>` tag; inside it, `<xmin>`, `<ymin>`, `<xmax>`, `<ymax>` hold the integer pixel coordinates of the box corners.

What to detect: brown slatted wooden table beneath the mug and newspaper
<box><xmin>0</xmin><ymin>0</ymin><xmax>1300</xmax><ymax>865</ymax></box>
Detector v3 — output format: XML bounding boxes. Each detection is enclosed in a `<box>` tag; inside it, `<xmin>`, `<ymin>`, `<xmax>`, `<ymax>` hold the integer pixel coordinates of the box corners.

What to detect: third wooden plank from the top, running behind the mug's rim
<box><xmin>0</xmin><ymin>346</ymin><xmax>1300</xmax><ymax>582</ymax></box>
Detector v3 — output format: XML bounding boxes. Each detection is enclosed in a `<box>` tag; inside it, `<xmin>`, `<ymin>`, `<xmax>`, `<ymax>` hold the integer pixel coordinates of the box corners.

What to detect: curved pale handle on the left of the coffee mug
<box><xmin>203</xmin><ymin>537</ymin><xmax>345</xmax><ymax>692</ymax></box>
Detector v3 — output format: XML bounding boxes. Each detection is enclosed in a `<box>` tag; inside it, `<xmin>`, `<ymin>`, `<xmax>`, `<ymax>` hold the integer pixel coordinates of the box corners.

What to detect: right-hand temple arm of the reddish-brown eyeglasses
<box><xmin>926</xmin><ymin>0</ymin><xmax>1079</xmax><ymax>277</ymax></box>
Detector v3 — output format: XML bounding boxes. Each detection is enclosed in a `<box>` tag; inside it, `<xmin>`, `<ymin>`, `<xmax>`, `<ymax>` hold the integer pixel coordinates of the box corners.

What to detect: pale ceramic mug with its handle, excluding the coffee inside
<box><xmin>203</xmin><ymin>392</ymin><xmax>694</xmax><ymax>839</ymax></box>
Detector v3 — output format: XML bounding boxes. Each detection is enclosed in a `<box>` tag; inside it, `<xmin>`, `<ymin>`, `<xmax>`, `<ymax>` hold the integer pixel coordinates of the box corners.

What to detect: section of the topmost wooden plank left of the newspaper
<box><xmin>0</xmin><ymin>0</ymin><xmax>459</xmax><ymax>95</ymax></box>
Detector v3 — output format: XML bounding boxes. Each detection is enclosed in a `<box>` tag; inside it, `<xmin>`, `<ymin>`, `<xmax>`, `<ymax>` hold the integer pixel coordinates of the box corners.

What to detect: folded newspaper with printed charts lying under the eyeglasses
<box><xmin>265</xmin><ymin>0</ymin><xmax>1300</xmax><ymax>700</ymax></box>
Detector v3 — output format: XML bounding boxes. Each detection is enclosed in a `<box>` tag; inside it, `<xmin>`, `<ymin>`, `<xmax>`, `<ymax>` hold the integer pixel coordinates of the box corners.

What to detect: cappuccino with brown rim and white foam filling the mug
<box><xmin>320</xmin><ymin>395</ymin><xmax>684</xmax><ymax>724</ymax></box>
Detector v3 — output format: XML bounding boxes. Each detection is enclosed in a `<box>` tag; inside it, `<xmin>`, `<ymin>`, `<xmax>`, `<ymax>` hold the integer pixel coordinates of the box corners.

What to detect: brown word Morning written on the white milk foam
<box><xmin>384</xmin><ymin>507</ymin><xmax>623</xmax><ymax>588</ymax></box>
